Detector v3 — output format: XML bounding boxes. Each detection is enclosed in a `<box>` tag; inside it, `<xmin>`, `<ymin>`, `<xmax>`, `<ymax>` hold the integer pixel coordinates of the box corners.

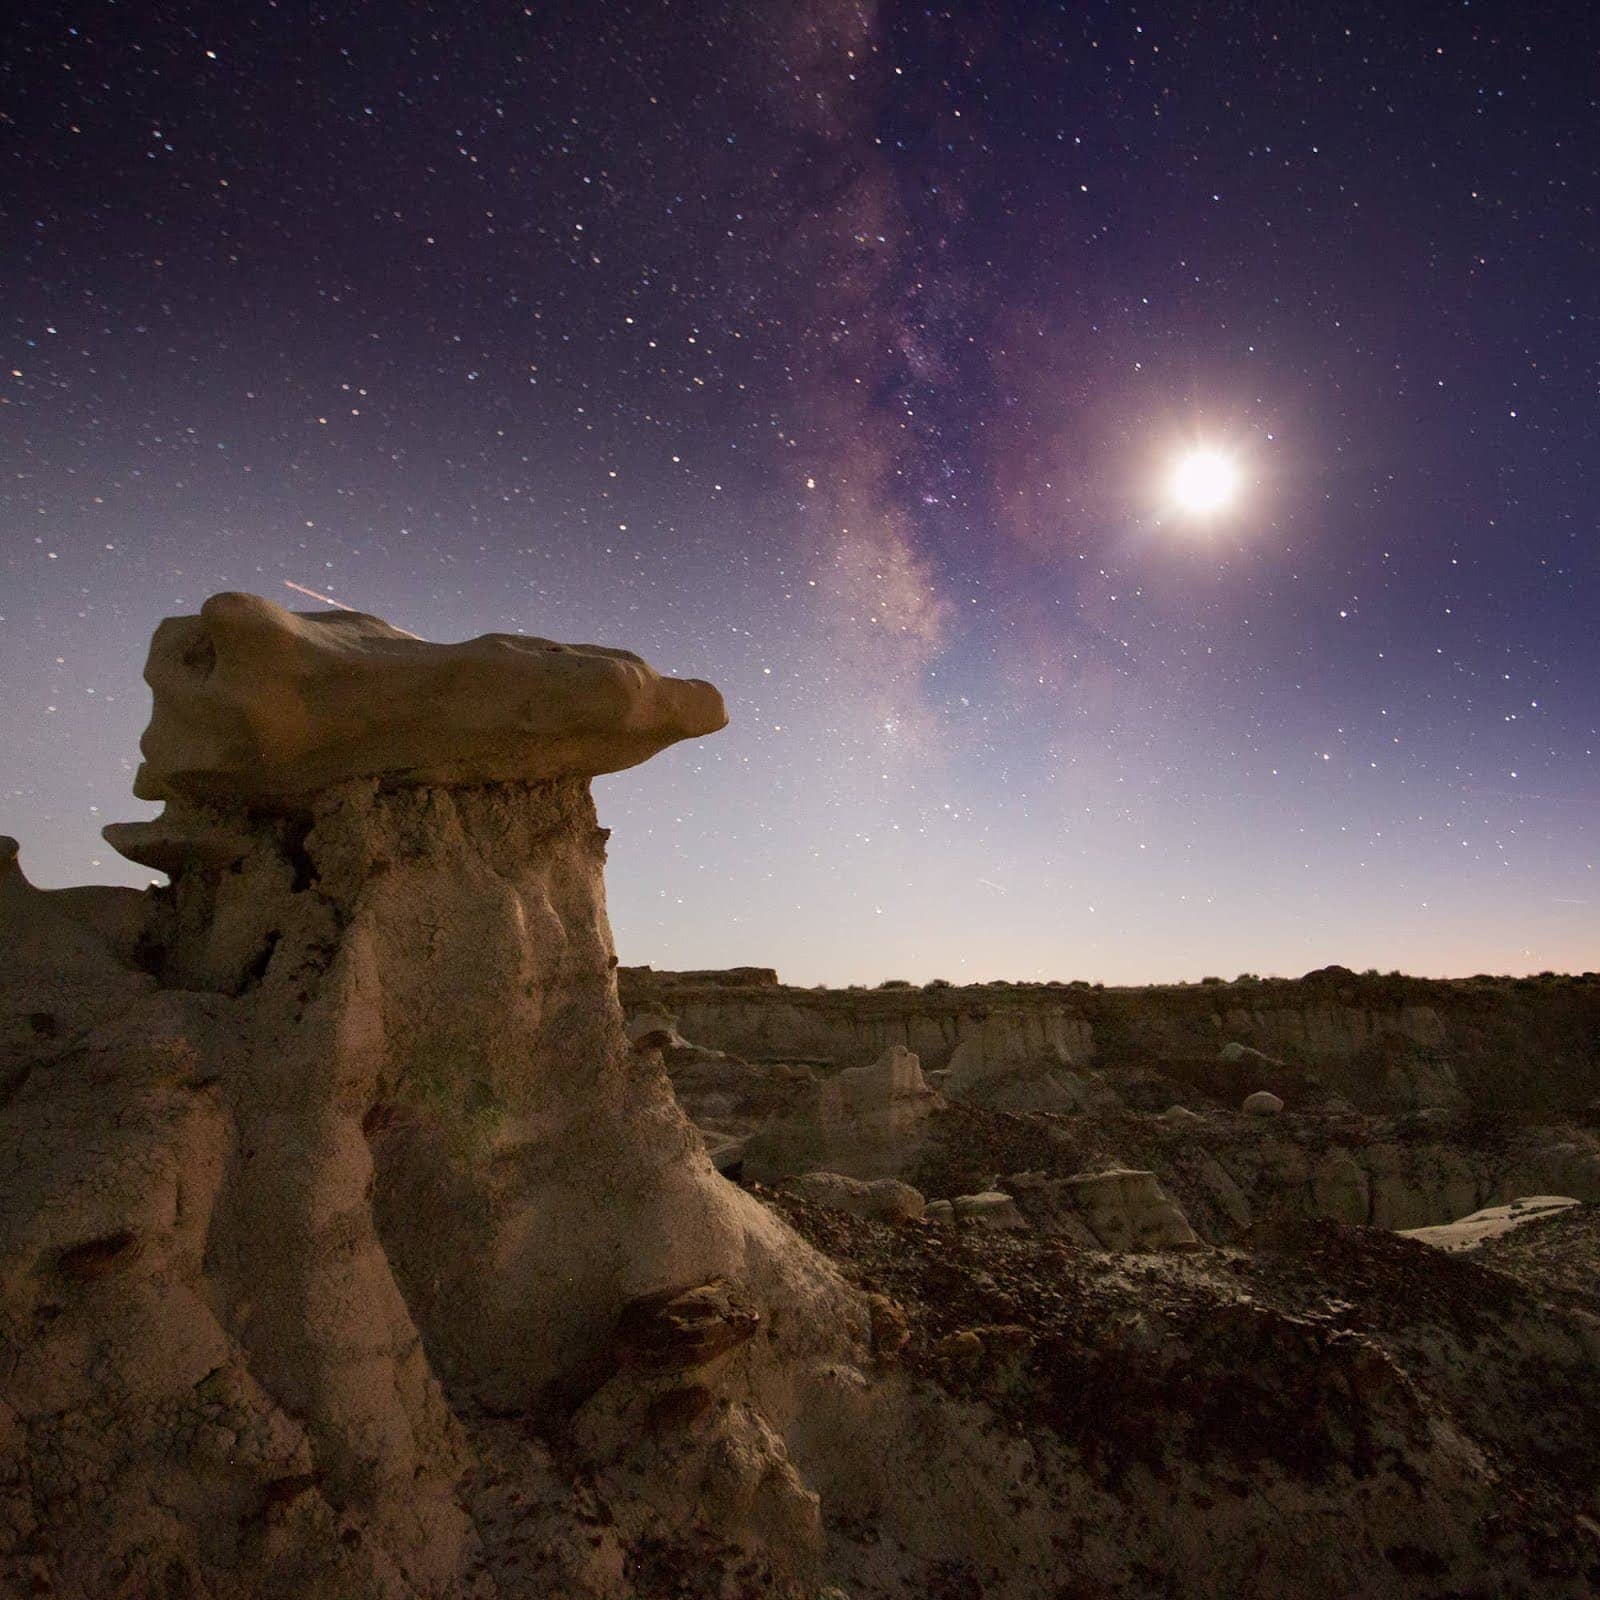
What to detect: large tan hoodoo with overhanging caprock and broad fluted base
<box><xmin>0</xmin><ymin>595</ymin><xmax>866</xmax><ymax>1595</ymax></box>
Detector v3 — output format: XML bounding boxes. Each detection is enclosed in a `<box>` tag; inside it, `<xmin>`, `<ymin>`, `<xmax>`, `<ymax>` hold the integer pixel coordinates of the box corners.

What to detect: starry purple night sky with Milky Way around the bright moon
<box><xmin>0</xmin><ymin>0</ymin><xmax>1600</xmax><ymax>982</ymax></box>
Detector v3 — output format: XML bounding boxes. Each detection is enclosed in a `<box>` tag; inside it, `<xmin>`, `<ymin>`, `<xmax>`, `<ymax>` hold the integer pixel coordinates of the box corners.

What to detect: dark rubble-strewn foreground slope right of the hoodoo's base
<box><xmin>758</xmin><ymin>1195</ymin><xmax>1600</xmax><ymax>1600</ymax></box>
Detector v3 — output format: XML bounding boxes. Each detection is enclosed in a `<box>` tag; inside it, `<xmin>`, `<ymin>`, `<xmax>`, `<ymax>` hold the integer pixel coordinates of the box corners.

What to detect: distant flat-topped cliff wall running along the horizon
<box><xmin>622</xmin><ymin>968</ymin><xmax>1600</xmax><ymax>1112</ymax></box>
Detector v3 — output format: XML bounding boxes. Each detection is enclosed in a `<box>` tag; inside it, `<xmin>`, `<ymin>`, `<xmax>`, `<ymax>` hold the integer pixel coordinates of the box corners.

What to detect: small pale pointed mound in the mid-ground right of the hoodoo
<box><xmin>744</xmin><ymin>1046</ymin><xmax>944</xmax><ymax>1182</ymax></box>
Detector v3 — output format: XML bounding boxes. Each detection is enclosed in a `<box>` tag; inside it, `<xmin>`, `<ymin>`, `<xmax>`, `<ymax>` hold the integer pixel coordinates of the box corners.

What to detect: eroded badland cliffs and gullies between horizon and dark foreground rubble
<box><xmin>622</xmin><ymin>970</ymin><xmax>1600</xmax><ymax>1243</ymax></box>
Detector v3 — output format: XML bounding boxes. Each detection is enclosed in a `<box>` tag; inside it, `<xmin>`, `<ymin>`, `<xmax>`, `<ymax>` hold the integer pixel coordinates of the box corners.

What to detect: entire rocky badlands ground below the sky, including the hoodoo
<box><xmin>0</xmin><ymin>595</ymin><xmax>1600</xmax><ymax>1600</ymax></box>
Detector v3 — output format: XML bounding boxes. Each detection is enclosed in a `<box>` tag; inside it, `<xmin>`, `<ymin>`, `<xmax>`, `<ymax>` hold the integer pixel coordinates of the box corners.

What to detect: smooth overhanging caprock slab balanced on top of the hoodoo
<box><xmin>121</xmin><ymin>594</ymin><xmax>728</xmax><ymax>811</ymax></box>
